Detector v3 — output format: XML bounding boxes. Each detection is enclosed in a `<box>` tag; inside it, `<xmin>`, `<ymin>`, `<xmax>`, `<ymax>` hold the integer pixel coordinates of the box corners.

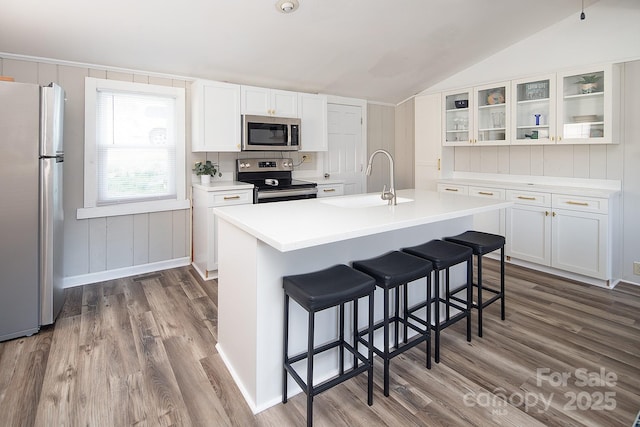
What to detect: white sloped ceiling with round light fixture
<box><xmin>0</xmin><ymin>0</ymin><xmax>597</xmax><ymax>104</ymax></box>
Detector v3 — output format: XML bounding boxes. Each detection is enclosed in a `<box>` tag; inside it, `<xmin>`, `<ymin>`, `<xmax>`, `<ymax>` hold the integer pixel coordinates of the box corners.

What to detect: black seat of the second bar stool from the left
<box><xmin>353</xmin><ymin>251</ymin><xmax>433</xmax><ymax>288</ymax></box>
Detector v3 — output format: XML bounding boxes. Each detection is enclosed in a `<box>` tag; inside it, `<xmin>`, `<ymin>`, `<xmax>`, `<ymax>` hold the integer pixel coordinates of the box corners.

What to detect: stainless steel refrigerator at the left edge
<box><xmin>0</xmin><ymin>81</ymin><xmax>64</xmax><ymax>341</ymax></box>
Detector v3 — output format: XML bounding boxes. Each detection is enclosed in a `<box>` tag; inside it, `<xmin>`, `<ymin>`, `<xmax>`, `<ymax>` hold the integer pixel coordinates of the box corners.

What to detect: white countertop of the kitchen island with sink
<box><xmin>214</xmin><ymin>189</ymin><xmax>513</xmax><ymax>252</ymax></box>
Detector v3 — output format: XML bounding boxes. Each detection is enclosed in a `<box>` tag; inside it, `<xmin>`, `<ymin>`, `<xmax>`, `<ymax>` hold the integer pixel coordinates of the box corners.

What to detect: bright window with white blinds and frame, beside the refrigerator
<box><xmin>78</xmin><ymin>77</ymin><xmax>189</xmax><ymax>219</ymax></box>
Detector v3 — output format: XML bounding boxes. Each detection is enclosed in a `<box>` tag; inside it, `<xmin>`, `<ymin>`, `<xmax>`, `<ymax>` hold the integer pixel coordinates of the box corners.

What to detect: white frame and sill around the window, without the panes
<box><xmin>77</xmin><ymin>77</ymin><xmax>191</xmax><ymax>219</ymax></box>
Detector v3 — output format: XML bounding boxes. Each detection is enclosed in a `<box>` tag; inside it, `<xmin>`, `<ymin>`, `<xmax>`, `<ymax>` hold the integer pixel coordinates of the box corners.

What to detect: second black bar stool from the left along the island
<box><xmin>352</xmin><ymin>251</ymin><xmax>433</xmax><ymax>396</ymax></box>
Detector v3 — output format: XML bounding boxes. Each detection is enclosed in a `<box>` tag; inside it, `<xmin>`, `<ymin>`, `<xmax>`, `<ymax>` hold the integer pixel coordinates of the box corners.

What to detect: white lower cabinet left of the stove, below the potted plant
<box><xmin>193</xmin><ymin>186</ymin><xmax>253</xmax><ymax>280</ymax></box>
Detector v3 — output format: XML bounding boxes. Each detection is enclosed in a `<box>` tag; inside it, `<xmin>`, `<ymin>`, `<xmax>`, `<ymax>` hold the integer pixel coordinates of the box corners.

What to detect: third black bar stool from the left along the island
<box><xmin>402</xmin><ymin>239</ymin><xmax>473</xmax><ymax>363</ymax></box>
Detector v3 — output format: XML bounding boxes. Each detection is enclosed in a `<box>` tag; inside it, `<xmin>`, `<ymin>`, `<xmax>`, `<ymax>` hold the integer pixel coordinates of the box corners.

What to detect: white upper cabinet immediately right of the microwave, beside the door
<box><xmin>298</xmin><ymin>93</ymin><xmax>329</xmax><ymax>151</ymax></box>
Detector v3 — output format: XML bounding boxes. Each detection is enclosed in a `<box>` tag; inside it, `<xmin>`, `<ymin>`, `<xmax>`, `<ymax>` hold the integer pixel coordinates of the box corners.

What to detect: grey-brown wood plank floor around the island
<box><xmin>0</xmin><ymin>261</ymin><xmax>640</xmax><ymax>427</ymax></box>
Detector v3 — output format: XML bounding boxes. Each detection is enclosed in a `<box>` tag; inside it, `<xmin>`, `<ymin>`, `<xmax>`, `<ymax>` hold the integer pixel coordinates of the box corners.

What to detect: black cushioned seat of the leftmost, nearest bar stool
<box><xmin>282</xmin><ymin>264</ymin><xmax>376</xmax><ymax>311</ymax></box>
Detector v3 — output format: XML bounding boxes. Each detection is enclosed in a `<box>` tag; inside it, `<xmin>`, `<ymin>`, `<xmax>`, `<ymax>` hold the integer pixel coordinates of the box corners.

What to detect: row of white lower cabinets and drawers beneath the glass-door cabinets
<box><xmin>438</xmin><ymin>182</ymin><xmax>617</xmax><ymax>285</ymax></box>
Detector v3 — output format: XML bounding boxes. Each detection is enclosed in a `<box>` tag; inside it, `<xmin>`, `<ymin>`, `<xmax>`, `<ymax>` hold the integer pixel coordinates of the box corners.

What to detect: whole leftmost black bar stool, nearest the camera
<box><xmin>282</xmin><ymin>264</ymin><xmax>375</xmax><ymax>426</ymax></box>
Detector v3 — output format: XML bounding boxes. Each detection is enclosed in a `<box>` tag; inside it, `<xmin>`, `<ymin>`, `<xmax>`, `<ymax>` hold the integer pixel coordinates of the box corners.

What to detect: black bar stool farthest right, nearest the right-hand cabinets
<box><xmin>444</xmin><ymin>230</ymin><xmax>505</xmax><ymax>337</ymax></box>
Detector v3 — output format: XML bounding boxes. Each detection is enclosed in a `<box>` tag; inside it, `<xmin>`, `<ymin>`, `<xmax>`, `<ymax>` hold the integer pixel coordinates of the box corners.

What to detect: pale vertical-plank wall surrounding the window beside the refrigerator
<box><xmin>0</xmin><ymin>58</ymin><xmax>191</xmax><ymax>286</ymax></box>
